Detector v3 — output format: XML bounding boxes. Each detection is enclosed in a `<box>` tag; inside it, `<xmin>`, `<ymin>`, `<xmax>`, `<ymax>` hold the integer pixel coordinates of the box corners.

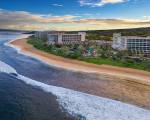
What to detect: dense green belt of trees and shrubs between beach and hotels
<box><xmin>28</xmin><ymin>38</ymin><xmax>150</xmax><ymax>71</ymax></box>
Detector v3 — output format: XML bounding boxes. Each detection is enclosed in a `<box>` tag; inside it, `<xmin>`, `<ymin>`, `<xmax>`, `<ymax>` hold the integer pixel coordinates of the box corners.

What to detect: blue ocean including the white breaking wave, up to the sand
<box><xmin>0</xmin><ymin>33</ymin><xmax>150</xmax><ymax>120</ymax></box>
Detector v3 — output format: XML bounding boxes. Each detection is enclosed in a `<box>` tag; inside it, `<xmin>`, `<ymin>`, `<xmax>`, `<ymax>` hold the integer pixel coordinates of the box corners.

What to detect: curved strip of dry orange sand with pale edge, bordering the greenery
<box><xmin>8</xmin><ymin>38</ymin><xmax>150</xmax><ymax>85</ymax></box>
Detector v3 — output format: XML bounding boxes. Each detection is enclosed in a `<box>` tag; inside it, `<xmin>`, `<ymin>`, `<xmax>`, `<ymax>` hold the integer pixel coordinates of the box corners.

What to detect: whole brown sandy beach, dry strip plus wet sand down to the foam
<box><xmin>10</xmin><ymin>39</ymin><xmax>150</xmax><ymax>109</ymax></box>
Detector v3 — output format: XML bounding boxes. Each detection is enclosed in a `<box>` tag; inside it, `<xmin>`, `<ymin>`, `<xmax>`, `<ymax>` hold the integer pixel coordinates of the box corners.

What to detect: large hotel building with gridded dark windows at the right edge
<box><xmin>112</xmin><ymin>33</ymin><xmax>150</xmax><ymax>54</ymax></box>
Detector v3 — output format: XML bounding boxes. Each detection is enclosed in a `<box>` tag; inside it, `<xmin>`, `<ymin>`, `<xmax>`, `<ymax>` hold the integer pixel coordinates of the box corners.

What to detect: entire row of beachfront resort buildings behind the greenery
<box><xmin>35</xmin><ymin>31</ymin><xmax>150</xmax><ymax>55</ymax></box>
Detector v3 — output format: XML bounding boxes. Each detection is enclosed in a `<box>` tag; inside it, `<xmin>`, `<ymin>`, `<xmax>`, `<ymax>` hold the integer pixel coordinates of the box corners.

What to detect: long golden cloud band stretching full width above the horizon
<box><xmin>0</xmin><ymin>9</ymin><xmax>150</xmax><ymax>31</ymax></box>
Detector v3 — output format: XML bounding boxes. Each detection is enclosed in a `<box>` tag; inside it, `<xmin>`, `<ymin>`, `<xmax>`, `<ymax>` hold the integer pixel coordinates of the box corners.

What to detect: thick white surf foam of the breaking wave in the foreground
<box><xmin>0</xmin><ymin>62</ymin><xmax>150</xmax><ymax>120</ymax></box>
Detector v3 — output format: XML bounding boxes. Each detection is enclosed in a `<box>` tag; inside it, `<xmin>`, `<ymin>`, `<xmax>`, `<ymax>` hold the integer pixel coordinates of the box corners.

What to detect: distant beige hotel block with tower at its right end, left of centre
<box><xmin>48</xmin><ymin>32</ymin><xmax>86</xmax><ymax>45</ymax></box>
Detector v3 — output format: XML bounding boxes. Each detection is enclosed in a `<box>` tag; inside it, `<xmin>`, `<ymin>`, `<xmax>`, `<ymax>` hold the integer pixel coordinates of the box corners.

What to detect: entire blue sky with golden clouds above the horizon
<box><xmin>0</xmin><ymin>0</ymin><xmax>150</xmax><ymax>31</ymax></box>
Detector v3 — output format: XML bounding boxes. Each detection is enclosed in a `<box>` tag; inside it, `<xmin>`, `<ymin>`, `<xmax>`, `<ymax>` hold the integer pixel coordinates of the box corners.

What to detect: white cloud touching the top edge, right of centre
<box><xmin>79</xmin><ymin>0</ymin><xmax>129</xmax><ymax>7</ymax></box>
